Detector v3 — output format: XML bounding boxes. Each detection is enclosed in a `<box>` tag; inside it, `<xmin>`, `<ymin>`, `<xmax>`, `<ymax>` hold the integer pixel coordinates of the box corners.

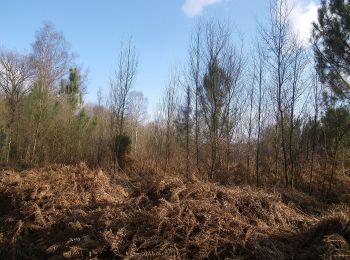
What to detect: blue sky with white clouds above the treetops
<box><xmin>0</xmin><ymin>0</ymin><xmax>318</xmax><ymax>113</ymax></box>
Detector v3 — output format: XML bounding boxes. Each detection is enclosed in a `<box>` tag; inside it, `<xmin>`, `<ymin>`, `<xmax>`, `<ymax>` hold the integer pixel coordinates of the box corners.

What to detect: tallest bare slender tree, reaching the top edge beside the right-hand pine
<box><xmin>260</xmin><ymin>0</ymin><xmax>295</xmax><ymax>186</ymax></box>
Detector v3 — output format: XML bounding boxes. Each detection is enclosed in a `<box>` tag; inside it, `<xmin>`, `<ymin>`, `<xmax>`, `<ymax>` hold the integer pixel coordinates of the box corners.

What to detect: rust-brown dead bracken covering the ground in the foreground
<box><xmin>0</xmin><ymin>164</ymin><xmax>350</xmax><ymax>259</ymax></box>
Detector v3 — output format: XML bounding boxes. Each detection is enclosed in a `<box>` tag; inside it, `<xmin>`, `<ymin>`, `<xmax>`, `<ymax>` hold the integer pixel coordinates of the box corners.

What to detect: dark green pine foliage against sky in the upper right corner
<box><xmin>313</xmin><ymin>0</ymin><xmax>350</xmax><ymax>101</ymax></box>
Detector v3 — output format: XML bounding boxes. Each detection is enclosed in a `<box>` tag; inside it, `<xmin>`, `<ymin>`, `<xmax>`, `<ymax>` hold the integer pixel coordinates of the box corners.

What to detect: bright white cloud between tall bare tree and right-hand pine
<box><xmin>291</xmin><ymin>0</ymin><xmax>320</xmax><ymax>46</ymax></box>
